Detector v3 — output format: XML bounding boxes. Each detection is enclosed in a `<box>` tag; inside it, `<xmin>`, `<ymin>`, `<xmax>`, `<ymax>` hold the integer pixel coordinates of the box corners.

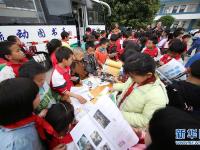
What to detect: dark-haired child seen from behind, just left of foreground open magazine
<box><xmin>45</xmin><ymin>102</ymin><xmax>75</xmax><ymax>149</ymax></box>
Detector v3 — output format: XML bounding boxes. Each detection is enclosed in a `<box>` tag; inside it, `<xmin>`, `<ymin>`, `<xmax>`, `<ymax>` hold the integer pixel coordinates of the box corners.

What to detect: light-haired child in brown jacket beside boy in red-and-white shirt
<box><xmin>71</xmin><ymin>47</ymin><xmax>88</xmax><ymax>81</ymax></box>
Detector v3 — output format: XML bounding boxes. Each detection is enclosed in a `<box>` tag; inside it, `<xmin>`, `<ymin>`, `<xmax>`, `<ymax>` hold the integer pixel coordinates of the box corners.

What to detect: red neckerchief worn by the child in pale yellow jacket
<box><xmin>118</xmin><ymin>75</ymin><xmax>156</xmax><ymax>108</ymax></box>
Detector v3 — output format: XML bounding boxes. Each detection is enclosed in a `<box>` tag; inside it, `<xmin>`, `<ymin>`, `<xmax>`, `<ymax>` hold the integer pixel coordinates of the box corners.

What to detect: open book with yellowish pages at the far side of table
<box><xmin>103</xmin><ymin>59</ymin><xmax>122</xmax><ymax>76</ymax></box>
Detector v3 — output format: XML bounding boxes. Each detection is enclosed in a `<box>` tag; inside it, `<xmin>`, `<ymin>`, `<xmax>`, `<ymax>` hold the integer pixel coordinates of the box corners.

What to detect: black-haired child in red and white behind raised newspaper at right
<box><xmin>160</xmin><ymin>39</ymin><xmax>185</xmax><ymax>65</ymax></box>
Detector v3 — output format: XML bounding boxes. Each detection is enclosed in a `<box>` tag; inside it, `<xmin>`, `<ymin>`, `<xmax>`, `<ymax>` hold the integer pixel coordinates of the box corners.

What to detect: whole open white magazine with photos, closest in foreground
<box><xmin>70</xmin><ymin>95</ymin><xmax>139</xmax><ymax>150</ymax></box>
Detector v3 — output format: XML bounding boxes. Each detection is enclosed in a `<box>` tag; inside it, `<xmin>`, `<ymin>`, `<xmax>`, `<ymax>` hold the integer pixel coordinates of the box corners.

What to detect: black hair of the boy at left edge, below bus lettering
<box><xmin>0</xmin><ymin>41</ymin><xmax>15</xmax><ymax>60</ymax></box>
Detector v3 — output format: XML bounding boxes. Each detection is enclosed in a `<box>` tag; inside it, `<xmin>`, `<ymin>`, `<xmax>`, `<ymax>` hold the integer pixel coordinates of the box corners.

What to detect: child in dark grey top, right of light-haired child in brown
<box><xmin>84</xmin><ymin>42</ymin><xmax>99</xmax><ymax>75</ymax></box>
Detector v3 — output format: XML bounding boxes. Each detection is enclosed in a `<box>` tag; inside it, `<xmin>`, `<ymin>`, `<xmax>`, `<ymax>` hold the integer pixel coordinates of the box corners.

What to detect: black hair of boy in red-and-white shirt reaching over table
<box><xmin>55</xmin><ymin>46</ymin><xmax>73</xmax><ymax>63</ymax></box>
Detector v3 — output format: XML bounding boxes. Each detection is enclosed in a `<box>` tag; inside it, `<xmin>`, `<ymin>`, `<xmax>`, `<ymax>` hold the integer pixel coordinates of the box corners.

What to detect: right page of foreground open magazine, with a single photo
<box><xmin>89</xmin><ymin>95</ymin><xmax>139</xmax><ymax>150</ymax></box>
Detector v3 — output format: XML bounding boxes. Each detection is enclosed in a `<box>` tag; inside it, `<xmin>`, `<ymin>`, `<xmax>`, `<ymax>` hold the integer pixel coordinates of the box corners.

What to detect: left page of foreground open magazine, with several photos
<box><xmin>70</xmin><ymin>115</ymin><xmax>116</xmax><ymax>150</ymax></box>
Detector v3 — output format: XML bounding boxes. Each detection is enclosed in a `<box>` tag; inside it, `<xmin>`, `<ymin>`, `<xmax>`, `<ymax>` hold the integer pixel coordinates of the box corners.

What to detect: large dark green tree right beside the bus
<box><xmin>104</xmin><ymin>0</ymin><xmax>160</xmax><ymax>28</ymax></box>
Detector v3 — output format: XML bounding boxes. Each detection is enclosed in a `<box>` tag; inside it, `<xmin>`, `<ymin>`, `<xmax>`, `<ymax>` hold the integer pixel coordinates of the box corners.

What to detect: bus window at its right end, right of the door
<box><xmin>87</xmin><ymin>0</ymin><xmax>105</xmax><ymax>25</ymax></box>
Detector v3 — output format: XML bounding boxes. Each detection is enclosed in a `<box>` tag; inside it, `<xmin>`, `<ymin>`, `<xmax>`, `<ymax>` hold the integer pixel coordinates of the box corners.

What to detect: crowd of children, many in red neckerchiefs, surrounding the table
<box><xmin>0</xmin><ymin>23</ymin><xmax>200</xmax><ymax>150</ymax></box>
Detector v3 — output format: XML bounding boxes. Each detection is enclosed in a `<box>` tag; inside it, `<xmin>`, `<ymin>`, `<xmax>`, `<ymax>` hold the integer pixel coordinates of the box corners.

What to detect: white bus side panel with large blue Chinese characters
<box><xmin>0</xmin><ymin>25</ymin><xmax>77</xmax><ymax>51</ymax></box>
